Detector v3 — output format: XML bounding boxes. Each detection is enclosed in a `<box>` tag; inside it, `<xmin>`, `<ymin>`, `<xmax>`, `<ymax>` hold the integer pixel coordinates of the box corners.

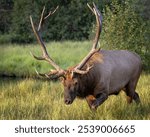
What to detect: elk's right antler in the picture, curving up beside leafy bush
<box><xmin>74</xmin><ymin>3</ymin><xmax>102</xmax><ymax>74</ymax></box>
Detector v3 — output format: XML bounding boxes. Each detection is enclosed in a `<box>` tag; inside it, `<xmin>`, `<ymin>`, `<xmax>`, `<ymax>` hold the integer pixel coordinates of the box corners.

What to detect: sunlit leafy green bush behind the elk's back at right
<box><xmin>101</xmin><ymin>0</ymin><xmax>150</xmax><ymax>68</ymax></box>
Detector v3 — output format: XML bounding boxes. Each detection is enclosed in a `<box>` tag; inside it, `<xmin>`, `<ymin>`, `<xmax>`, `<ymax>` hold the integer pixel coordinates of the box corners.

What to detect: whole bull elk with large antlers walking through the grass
<box><xmin>30</xmin><ymin>3</ymin><xmax>142</xmax><ymax>109</ymax></box>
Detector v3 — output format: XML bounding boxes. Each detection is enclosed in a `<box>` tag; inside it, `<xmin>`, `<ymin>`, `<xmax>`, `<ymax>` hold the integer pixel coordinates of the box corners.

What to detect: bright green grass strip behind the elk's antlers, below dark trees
<box><xmin>0</xmin><ymin>41</ymin><xmax>91</xmax><ymax>77</ymax></box>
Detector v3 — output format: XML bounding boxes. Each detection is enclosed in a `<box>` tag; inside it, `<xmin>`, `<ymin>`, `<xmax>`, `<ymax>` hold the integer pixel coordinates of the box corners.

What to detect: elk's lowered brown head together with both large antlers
<box><xmin>30</xmin><ymin>3</ymin><xmax>102</xmax><ymax>104</ymax></box>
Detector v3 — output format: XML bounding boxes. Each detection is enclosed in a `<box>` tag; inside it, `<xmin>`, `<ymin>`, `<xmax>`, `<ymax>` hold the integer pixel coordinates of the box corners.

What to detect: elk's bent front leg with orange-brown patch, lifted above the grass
<box><xmin>86</xmin><ymin>93</ymin><xmax>108</xmax><ymax>110</ymax></box>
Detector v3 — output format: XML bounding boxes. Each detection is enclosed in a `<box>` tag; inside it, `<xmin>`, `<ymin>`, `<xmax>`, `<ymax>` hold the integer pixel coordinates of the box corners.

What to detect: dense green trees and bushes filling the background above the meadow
<box><xmin>0</xmin><ymin>0</ymin><xmax>150</xmax><ymax>69</ymax></box>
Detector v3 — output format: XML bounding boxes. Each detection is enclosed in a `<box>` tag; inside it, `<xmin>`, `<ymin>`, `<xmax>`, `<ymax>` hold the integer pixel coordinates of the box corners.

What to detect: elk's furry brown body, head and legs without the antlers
<box><xmin>63</xmin><ymin>51</ymin><xmax>141</xmax><ymax>109</ymax></box>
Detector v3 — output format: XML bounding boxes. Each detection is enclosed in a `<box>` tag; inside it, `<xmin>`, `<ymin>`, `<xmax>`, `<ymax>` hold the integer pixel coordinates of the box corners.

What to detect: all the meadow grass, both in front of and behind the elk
<box><xmin>0</xmin><ymin>41</ymin><xmax>150</xmax><ymax>120</ymax></box>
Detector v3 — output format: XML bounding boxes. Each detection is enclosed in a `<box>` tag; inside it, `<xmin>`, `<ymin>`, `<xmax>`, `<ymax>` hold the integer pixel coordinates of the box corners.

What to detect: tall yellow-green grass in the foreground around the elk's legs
<box><xmin>0</xmin><ymin>74</ymin><xmax>150</xmax><ymax>120</ymax></box>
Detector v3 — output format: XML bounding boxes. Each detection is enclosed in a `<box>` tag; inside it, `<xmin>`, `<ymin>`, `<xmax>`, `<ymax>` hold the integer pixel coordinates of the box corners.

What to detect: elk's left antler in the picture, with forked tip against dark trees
<box><xmin>30</xmin><ymin>6</ymin><xmax>65</xmax><ymax>78</ymax></box>
